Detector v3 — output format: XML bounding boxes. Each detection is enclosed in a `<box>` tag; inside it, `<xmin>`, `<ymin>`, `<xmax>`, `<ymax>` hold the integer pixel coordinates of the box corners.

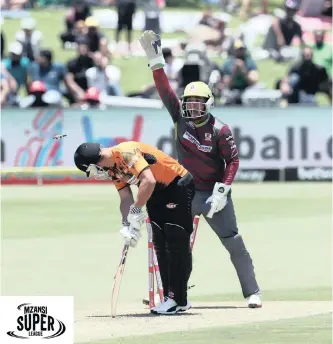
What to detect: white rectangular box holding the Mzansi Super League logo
<box><xmin>0</xmin><ymin>296</ymin><xmax>74</xmax><ymax>344</ymax></box>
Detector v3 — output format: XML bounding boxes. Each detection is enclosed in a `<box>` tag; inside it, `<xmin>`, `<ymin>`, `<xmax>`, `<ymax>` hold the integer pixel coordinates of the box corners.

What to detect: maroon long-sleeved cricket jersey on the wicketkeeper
<box><xmin>153</xmin><ymin>68</ymin><xmax>239</xmax><ymax>191</ymax></box>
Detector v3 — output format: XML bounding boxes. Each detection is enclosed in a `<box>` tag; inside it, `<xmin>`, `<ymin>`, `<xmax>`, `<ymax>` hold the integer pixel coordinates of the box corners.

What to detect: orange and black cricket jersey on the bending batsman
<box><xmin>109</xmin><ymin>141</ymin><xmax>188</xmax><ymax>190</ymax></box>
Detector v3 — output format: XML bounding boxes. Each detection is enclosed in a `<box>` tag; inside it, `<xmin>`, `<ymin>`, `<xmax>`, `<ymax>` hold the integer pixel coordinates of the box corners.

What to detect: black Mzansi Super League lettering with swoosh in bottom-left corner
<box><xmin>7</xmin><ymin>303</ymin><xmax>66</xmax><ymax>339</ymax></box>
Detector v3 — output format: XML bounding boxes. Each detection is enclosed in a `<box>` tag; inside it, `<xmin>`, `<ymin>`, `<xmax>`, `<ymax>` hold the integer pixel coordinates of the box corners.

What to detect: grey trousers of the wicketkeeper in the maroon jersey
<box><xmin>192</xmin><ymin>190</ymin><xmax>259</xmax><ymax>298</ymax></box>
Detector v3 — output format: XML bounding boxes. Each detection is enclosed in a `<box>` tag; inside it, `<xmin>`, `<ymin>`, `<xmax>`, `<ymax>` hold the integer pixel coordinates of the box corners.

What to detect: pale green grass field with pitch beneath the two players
<box><xmin>1</xmin><ymin>183</ymin><xmax>332</xmax><ymax>344</ymax></box>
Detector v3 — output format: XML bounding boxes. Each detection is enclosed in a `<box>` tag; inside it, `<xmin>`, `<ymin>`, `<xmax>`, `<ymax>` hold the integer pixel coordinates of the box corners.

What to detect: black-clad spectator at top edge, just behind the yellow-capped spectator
<box><xmin>60</xmin><ymin>0</ymin><xmax>91</xmax><ymax>47</ymax></box>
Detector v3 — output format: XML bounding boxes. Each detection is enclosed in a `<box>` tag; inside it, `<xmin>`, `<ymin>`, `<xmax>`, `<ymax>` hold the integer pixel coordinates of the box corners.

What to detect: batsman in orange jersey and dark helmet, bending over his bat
<box><xmin>74</xmin><ymin>142</ymin><xmax>195</xmax><ymax>315</ymax></box>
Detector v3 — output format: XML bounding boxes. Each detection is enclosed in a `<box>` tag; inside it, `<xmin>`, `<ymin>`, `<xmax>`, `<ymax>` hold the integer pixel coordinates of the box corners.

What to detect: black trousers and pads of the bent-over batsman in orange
<box><xmin>147</xmin><ymin>174</ymin><xmax>195</xmax><ymax>306</ymax></box>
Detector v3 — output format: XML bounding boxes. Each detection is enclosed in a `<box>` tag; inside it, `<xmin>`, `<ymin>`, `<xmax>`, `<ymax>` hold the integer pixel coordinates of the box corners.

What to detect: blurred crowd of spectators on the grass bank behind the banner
<box><xmin>1</xmin><ymin>0</ymin><xmax>332</xmax><ymax>107</ymax></box>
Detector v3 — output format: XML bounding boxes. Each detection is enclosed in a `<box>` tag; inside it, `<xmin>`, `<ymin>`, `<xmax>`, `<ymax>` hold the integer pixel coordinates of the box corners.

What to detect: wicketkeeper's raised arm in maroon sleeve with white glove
<box><xmin>139</xmin><ymin>31</ymin><xmax>181</xmax><ymax>122</ymax></box>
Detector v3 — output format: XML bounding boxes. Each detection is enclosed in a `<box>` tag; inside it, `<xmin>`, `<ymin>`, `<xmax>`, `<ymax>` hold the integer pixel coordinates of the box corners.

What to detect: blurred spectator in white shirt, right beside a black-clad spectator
<box><xmin>86</xmin><ymin>52</ymin><xmax>122</xmax><ymax>96</ymax></box>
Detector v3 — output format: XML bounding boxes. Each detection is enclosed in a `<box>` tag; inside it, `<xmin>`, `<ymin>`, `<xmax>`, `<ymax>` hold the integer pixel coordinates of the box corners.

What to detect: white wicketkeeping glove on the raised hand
<box><xmin>139</xmin><ymin>30</ymin><xmax>165</xmax><ymax>70</ymax></box>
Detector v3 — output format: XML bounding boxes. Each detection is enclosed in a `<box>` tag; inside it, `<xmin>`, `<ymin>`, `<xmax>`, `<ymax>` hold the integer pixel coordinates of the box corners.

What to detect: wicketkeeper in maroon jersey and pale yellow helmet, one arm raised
<box><xmin>139</xmin><ymin>31</ymin><xmax>262</xmax><ymax>308</ymax></box>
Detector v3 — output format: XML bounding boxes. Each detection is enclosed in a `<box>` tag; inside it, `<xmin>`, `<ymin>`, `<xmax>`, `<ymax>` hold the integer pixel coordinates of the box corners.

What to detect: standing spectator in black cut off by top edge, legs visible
<box><xmin>115</xmin><ymin>0</ymin><xmax>136</xmax><ymax>53</ymax></box>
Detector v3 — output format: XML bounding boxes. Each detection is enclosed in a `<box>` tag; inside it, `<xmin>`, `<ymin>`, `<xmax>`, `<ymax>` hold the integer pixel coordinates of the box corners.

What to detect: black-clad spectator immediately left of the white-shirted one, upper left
<box><xmin>67</xmin><ymin>40</ymin><xmax>94</xmax><ymax>104</ymax></box>
